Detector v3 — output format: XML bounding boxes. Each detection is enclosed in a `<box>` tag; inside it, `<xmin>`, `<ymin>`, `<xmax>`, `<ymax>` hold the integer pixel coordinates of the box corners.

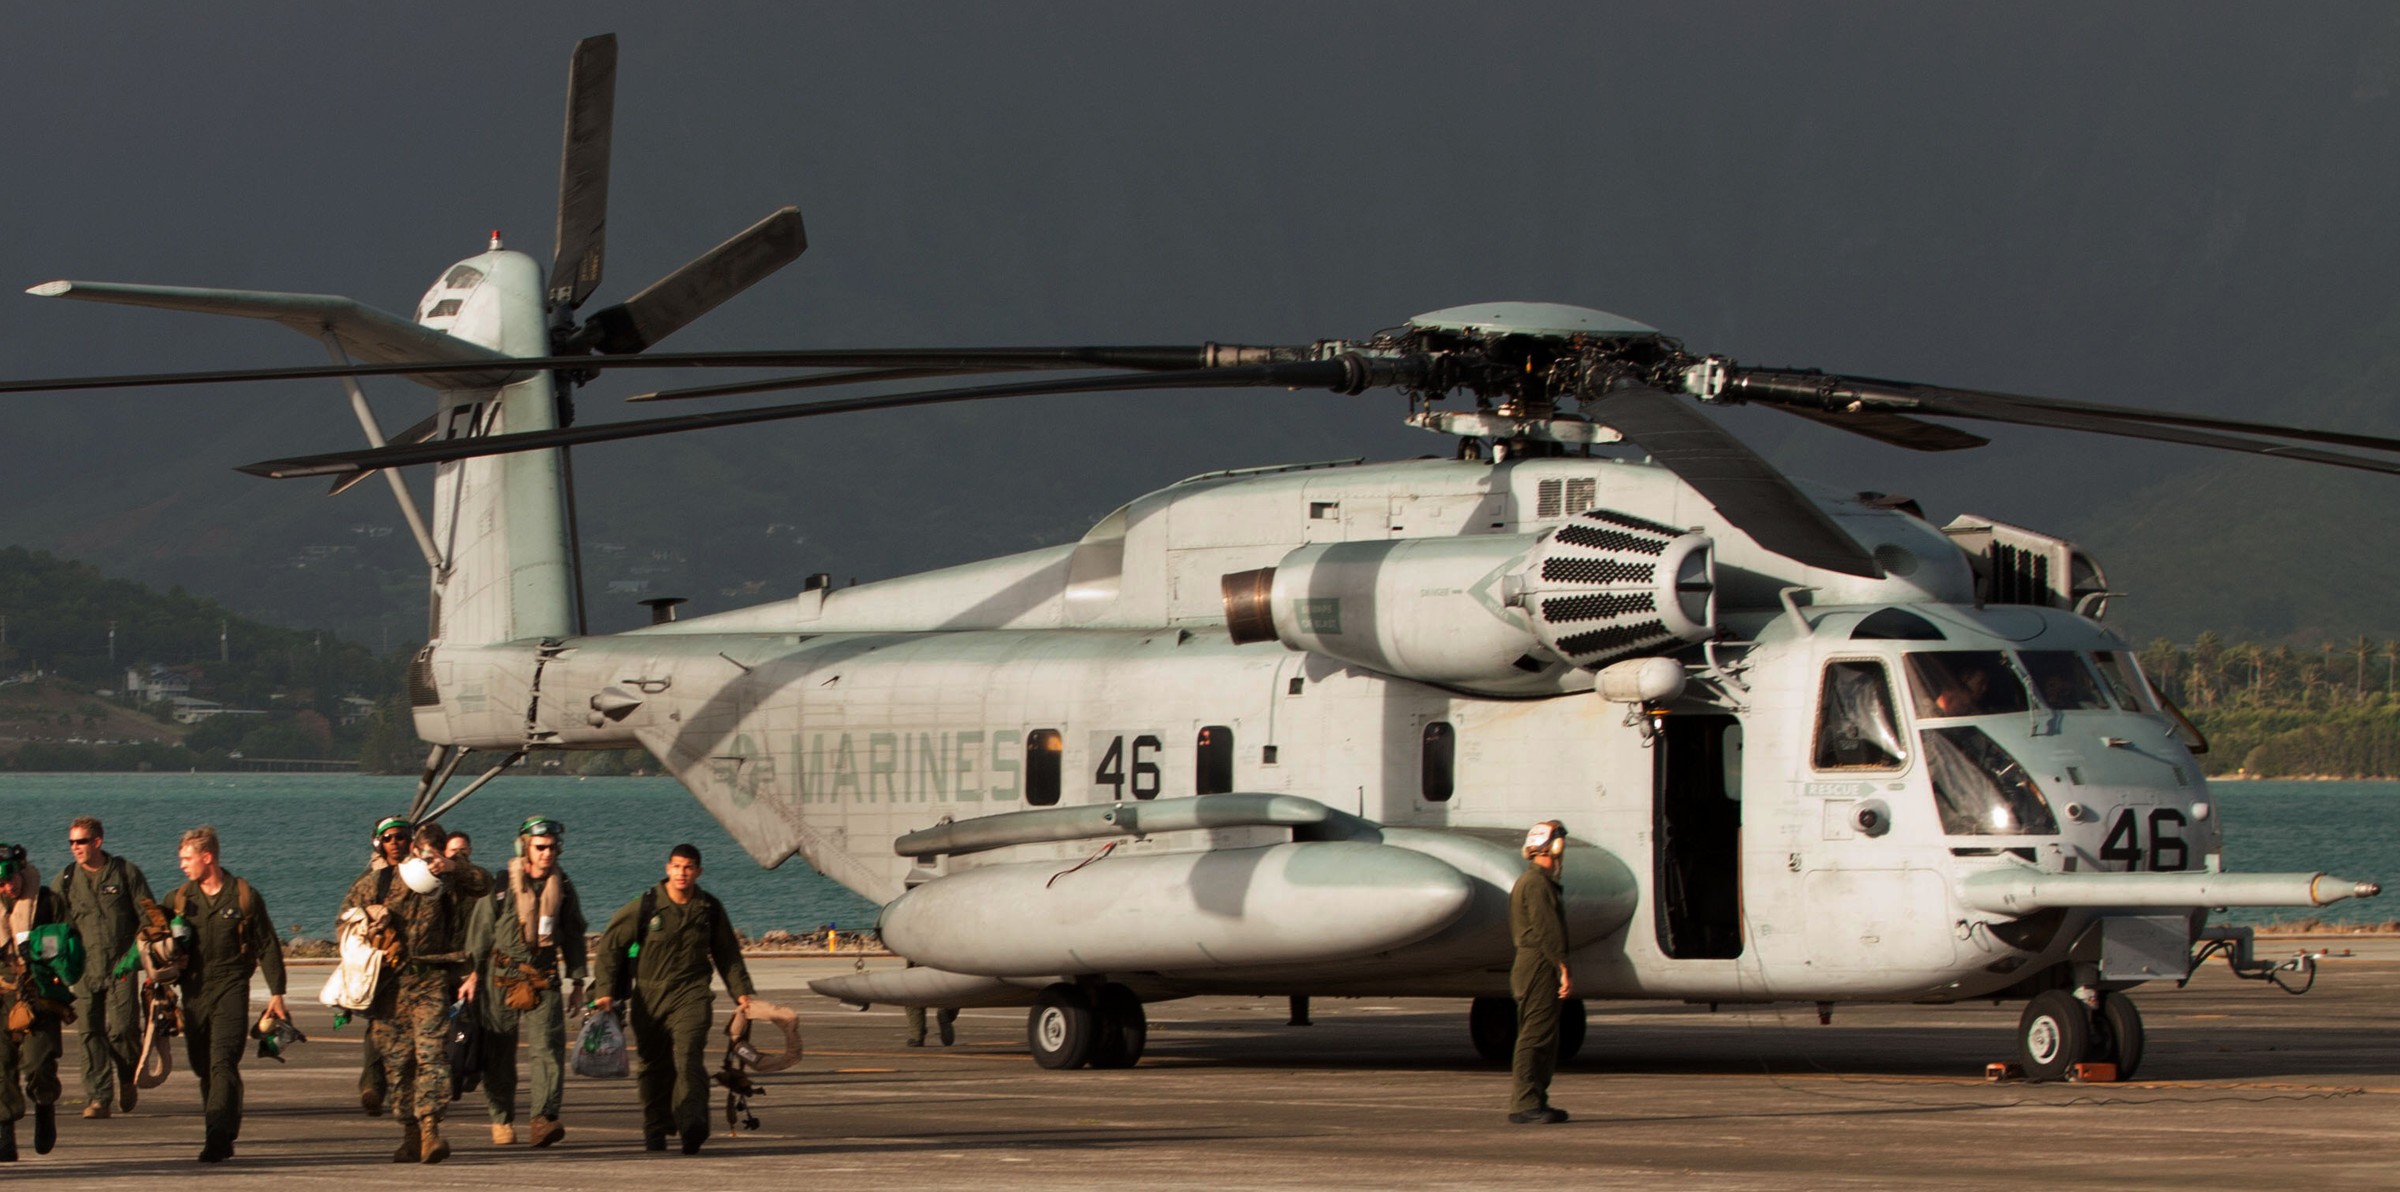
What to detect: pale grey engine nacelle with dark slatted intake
<box><xmin>1224</xmin><ymin>508</ymin><xmax>1716</xmax><ymax>696</ymax></box>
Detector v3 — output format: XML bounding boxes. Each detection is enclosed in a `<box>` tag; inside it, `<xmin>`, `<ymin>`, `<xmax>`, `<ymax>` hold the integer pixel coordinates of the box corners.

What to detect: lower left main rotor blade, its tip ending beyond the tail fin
<box><xmin>240</xmin><ymin>357</ymin><xmax>1418</xmax><ymax>480</ymax></box>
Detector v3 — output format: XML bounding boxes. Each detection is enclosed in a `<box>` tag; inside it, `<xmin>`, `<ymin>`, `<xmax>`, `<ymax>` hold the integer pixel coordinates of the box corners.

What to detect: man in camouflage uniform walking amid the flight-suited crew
<box><xmin>341</xmin><ymin>823</ymin><xmax>490</xmax><ymax>1163</ymax></box>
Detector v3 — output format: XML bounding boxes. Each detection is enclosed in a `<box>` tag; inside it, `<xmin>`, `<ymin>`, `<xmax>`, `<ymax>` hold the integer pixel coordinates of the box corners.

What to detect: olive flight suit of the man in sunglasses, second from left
<box><xmin>50</xmin><ymin>854</ymin><xmax>154</xmax><ymax>1108</ymax></box>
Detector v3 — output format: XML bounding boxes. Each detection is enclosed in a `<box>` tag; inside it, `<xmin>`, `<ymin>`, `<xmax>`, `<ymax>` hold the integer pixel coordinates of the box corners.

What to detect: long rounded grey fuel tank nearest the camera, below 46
<box><xmin>878</xmin><ymin>839</ymin><xmax>1474</xmax><ymax>976</ymax></box>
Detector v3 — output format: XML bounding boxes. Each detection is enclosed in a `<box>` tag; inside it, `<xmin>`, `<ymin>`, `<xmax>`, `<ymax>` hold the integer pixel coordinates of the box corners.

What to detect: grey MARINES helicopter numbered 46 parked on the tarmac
<box><xmin>5</xmin><ymin>38</ymin><xmax>2400</xmax><ymax>1077</ymax></box>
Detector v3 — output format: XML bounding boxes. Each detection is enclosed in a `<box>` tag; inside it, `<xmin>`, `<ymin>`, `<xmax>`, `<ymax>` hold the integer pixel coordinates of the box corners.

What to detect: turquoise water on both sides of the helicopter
<box><xmin>0</xmin><ymin>775</ymin><xmax>2400</xmax><ymax>938</ymax></box>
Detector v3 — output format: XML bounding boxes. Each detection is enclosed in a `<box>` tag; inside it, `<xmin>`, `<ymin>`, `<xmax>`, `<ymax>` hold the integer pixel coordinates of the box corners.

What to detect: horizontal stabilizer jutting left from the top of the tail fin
<box><xmin>26</xmin><ymin>281</ymin><xmax>526</xmax><ymax>389</ymax></box>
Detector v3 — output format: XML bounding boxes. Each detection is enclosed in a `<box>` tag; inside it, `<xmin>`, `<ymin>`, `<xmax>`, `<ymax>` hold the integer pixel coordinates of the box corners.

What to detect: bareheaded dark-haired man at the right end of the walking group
<box><xmin>593</xmin><ymin>844</ymin><xmax>754</xmax><ymax>1154</ymax></box>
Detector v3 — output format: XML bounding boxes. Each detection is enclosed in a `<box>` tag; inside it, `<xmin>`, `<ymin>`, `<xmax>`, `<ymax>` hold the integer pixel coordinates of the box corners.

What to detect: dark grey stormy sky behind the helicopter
<box><xmin>0</xmin><ymin>2</ymin><xmax>2400</xmax><ymax>638</ymax></box>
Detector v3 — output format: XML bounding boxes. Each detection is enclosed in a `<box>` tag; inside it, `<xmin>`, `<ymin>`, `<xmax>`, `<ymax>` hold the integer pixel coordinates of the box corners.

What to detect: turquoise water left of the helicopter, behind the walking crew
<box><xmin>0</xmin><ymin>775</ymin><xmax>876</xmax><ymax>938</ymax></box>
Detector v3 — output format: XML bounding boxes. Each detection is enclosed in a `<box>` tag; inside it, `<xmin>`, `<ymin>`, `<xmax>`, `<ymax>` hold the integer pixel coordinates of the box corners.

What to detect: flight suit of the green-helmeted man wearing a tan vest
<box><xmin>468</xmin><ymin>861</ymin><xmax>590</xmax><ymax>1127</ymax></box>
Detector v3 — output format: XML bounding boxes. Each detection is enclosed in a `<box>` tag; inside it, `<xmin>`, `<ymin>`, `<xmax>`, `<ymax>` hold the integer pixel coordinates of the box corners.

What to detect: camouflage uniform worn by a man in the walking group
<box><xmin>341</xmin><ymin>866</ymin><xmax>487</xmax><ymax>1149</ymax></box>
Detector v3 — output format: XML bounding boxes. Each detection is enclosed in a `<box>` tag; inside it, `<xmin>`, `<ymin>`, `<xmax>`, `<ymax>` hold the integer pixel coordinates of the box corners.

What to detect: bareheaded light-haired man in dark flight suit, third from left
<box><xmin>168</xmin><ymin>825</ymin><xmax>290</xmax><ymax>1163</ymax></box>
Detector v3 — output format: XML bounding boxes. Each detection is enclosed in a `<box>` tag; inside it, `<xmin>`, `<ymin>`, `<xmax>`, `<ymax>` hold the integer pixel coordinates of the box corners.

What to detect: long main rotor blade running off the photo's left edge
<box><xmin>0</xmin><ymin>343</ymin><xmax>1238</xmax><ymax>393</ymax></box>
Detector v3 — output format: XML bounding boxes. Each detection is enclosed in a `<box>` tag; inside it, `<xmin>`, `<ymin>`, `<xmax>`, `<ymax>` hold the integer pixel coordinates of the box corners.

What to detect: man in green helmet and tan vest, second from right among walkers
<box><xmin>451</xmin><ymin>815</ymin><xmax>588</xmax><ymax>1146</ymax></box>
